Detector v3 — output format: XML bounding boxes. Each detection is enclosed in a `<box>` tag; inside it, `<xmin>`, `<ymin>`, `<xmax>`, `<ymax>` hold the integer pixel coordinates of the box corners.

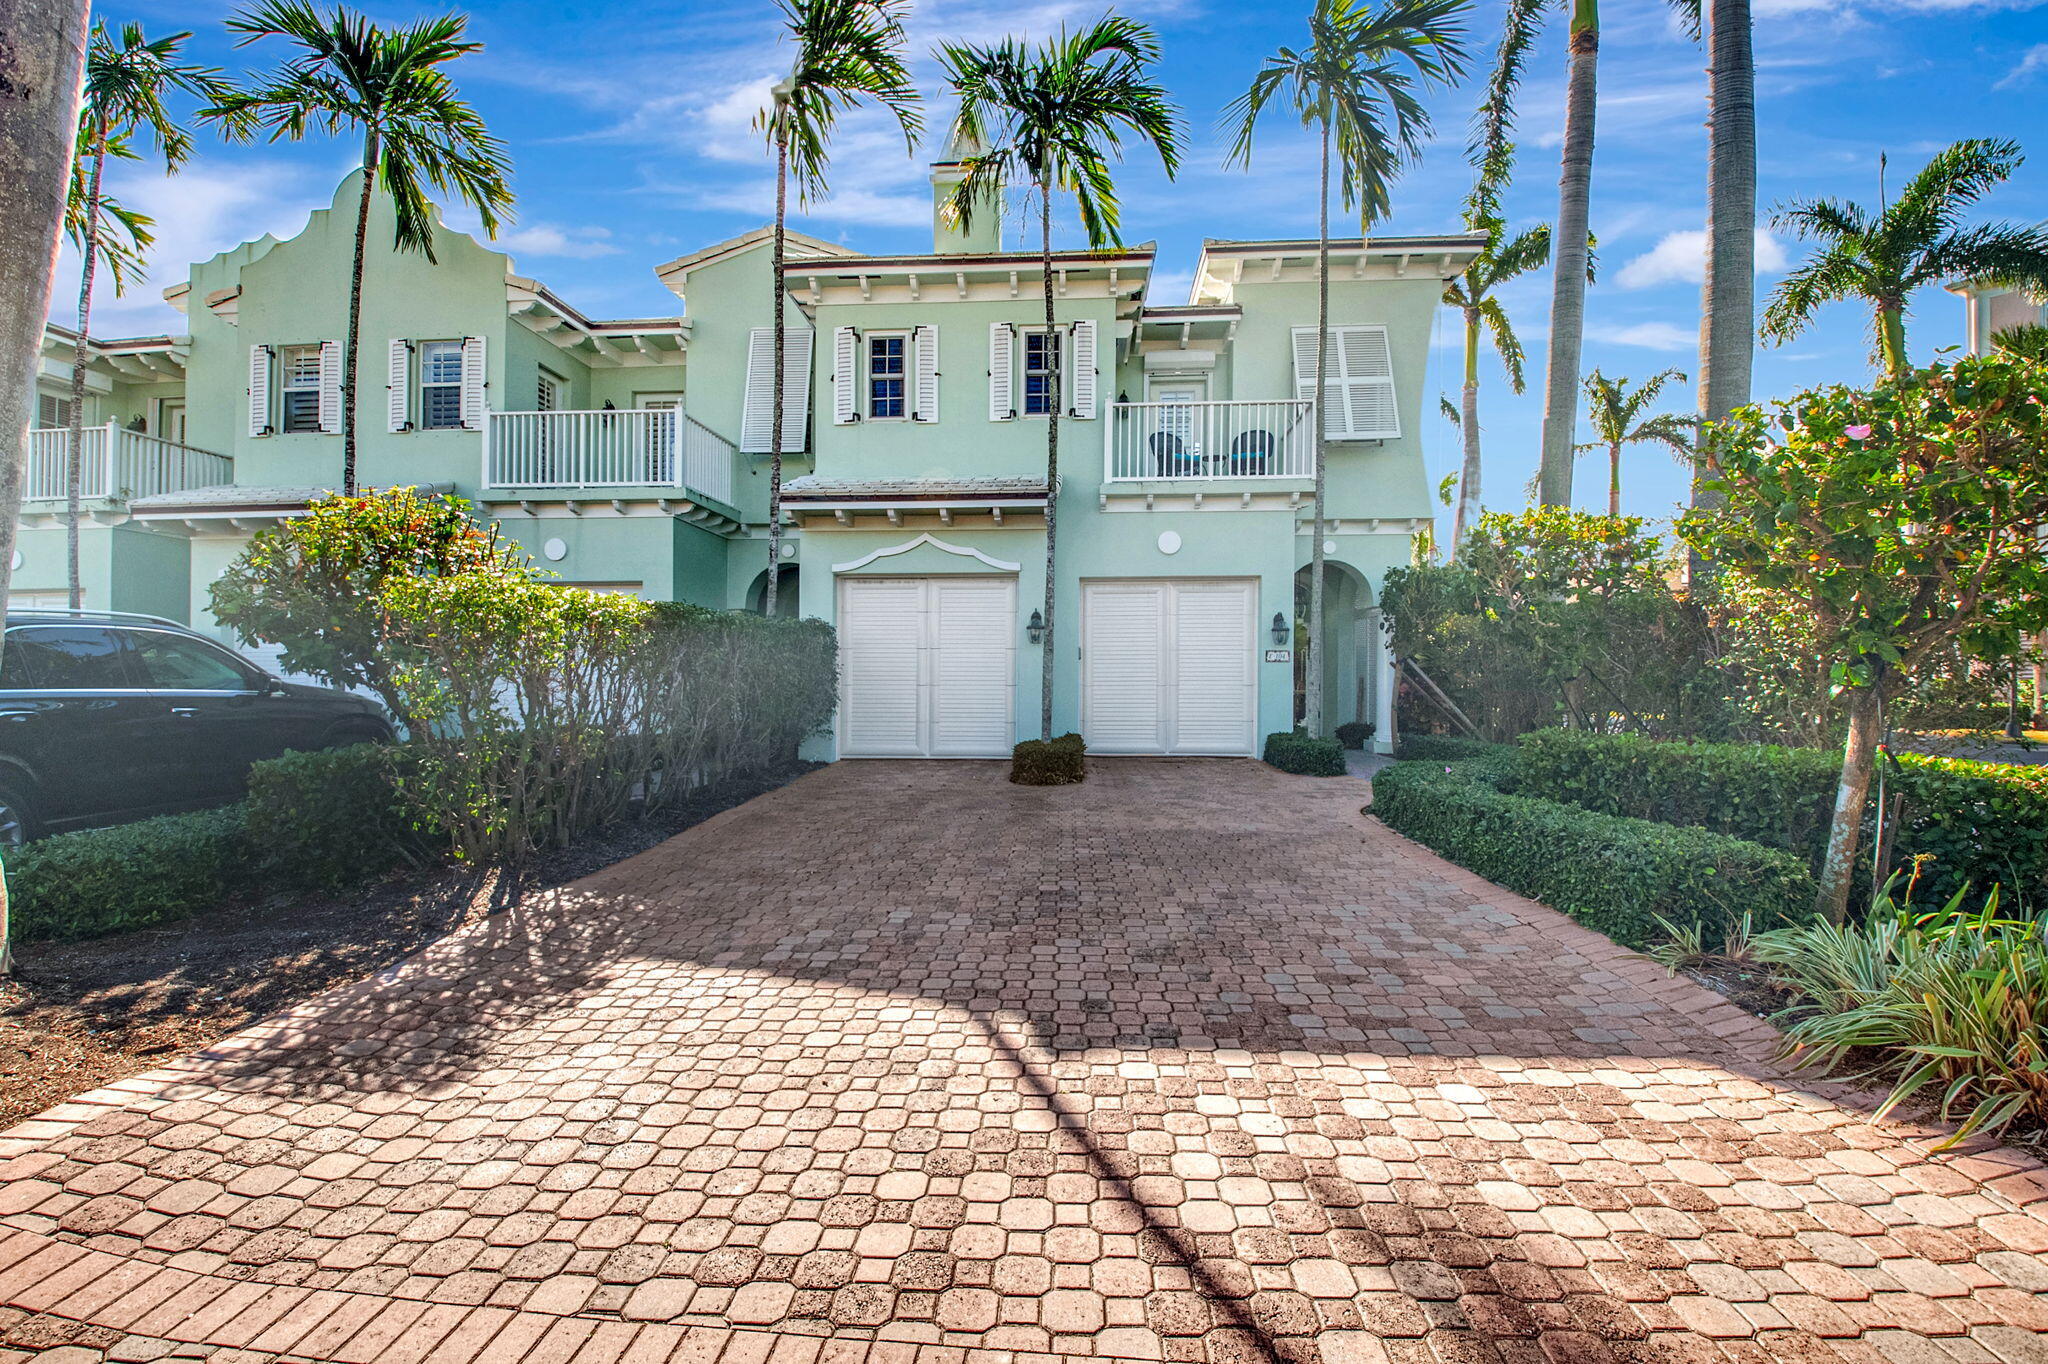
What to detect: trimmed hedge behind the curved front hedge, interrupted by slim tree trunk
<box><xmin>1516</xmin><ymin>729</ymin><xmax>2048</xmax><ymax>903</ymax></box>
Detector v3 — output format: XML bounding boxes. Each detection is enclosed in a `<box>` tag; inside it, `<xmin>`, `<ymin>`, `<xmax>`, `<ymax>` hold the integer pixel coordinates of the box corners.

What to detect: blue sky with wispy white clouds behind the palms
<box><xmin>55</xmin><ymin>0</ymin><xmax>2048</xmax><ymax>516</ymax></box>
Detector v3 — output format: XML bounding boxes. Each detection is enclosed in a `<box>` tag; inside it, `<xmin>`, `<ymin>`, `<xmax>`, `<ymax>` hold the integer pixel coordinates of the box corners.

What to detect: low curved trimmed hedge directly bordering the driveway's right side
<box><xmin>1368</xmin><ymin>762</ymin><xmax>1815</xmax><ymax>946</ymax></box>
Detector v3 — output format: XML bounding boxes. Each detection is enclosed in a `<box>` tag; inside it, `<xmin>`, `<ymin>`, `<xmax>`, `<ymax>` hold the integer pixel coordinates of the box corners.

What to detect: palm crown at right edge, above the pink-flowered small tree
<box><xmin>1763</xmin><ymin>137</ymin><xmax>2048</xmax><ymax>377</ymax></box>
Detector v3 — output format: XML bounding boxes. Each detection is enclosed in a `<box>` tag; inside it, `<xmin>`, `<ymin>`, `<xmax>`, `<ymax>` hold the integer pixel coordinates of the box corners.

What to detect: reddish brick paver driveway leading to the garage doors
<box><xmin>0</xmin><ymin>762</ymin><xmax>2048</xmax><ymax>1364</ymax></box>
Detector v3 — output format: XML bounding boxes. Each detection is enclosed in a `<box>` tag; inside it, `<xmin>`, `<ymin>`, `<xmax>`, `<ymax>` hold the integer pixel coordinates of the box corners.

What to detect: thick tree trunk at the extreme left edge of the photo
<box><xmin>0</xmin><ymin>0</ymin><xmax>86</xmax><ymax>975</ymax></box>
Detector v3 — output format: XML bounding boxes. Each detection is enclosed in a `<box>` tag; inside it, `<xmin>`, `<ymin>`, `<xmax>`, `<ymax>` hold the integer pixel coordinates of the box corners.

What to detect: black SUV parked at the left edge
<box><xmin>0</xmin><ymin>610</ymin><xmax>391</xmax><ymax>846</ymax></box>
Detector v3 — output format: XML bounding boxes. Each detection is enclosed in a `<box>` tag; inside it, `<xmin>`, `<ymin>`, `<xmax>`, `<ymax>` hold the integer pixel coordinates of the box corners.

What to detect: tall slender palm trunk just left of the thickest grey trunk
<box><xmin>1538</xmin><ymin>0</ymin><xmax>1599</xmax><ymax>506</ymax></box>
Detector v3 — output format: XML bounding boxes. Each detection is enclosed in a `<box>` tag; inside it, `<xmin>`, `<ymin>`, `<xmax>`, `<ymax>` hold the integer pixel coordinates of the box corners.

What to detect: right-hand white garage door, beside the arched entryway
<box><xmin>1081</xmin><ymin>580</ymin><xmax>1257</xmax><ymax>758</ymax></box>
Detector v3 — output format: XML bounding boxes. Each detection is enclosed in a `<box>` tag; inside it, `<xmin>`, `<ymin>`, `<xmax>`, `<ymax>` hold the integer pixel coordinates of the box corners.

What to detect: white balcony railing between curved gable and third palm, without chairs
<box><xmin>483</xmin><ymin>408</ymin><xmax>735</xmax><ymax>504</ymax></box>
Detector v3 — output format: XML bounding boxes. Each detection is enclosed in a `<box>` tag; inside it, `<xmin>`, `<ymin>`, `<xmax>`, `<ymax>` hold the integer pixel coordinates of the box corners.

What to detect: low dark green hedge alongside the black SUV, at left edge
<box><xmin>6</xmin><ymin>805</ymin><xmax>258</xmax><ymax>942</ymax></box>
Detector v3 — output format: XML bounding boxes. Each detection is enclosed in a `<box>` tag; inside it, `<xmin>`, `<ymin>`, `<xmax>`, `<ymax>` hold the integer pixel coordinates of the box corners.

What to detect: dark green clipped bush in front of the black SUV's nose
<box><xmin>248</xmin><ymin>743</ymin><xmax>428</xmax><ymax>891</ymax></box>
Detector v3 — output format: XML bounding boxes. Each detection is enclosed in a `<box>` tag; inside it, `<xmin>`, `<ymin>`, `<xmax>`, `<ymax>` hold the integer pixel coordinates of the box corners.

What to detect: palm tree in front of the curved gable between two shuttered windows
<box><xmin>207</xmin><ymin>0</ymin><xmax>512</xmax><ymax>496</ymax></box>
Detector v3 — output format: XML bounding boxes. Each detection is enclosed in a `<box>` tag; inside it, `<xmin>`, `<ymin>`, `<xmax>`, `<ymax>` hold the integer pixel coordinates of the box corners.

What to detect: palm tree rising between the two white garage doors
<box><xmin>938</xmin><ymin>14</ymin><xmax>1182</xmax><ymax>739</ymax></box>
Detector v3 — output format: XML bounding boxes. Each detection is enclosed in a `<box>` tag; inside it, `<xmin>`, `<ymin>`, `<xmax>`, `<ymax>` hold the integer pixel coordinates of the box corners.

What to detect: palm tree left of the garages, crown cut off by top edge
<box><xmin>756</xmin><ymin>0</ymin><xmax>924</xmax><ymax>616</ymax></box>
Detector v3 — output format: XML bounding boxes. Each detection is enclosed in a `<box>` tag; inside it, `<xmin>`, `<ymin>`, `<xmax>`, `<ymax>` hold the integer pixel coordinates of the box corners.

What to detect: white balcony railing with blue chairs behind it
<box><xmin>1102</xmin><ymin>397</ymin><xmax>1315</xmax><ymax>483</ymax></box>
